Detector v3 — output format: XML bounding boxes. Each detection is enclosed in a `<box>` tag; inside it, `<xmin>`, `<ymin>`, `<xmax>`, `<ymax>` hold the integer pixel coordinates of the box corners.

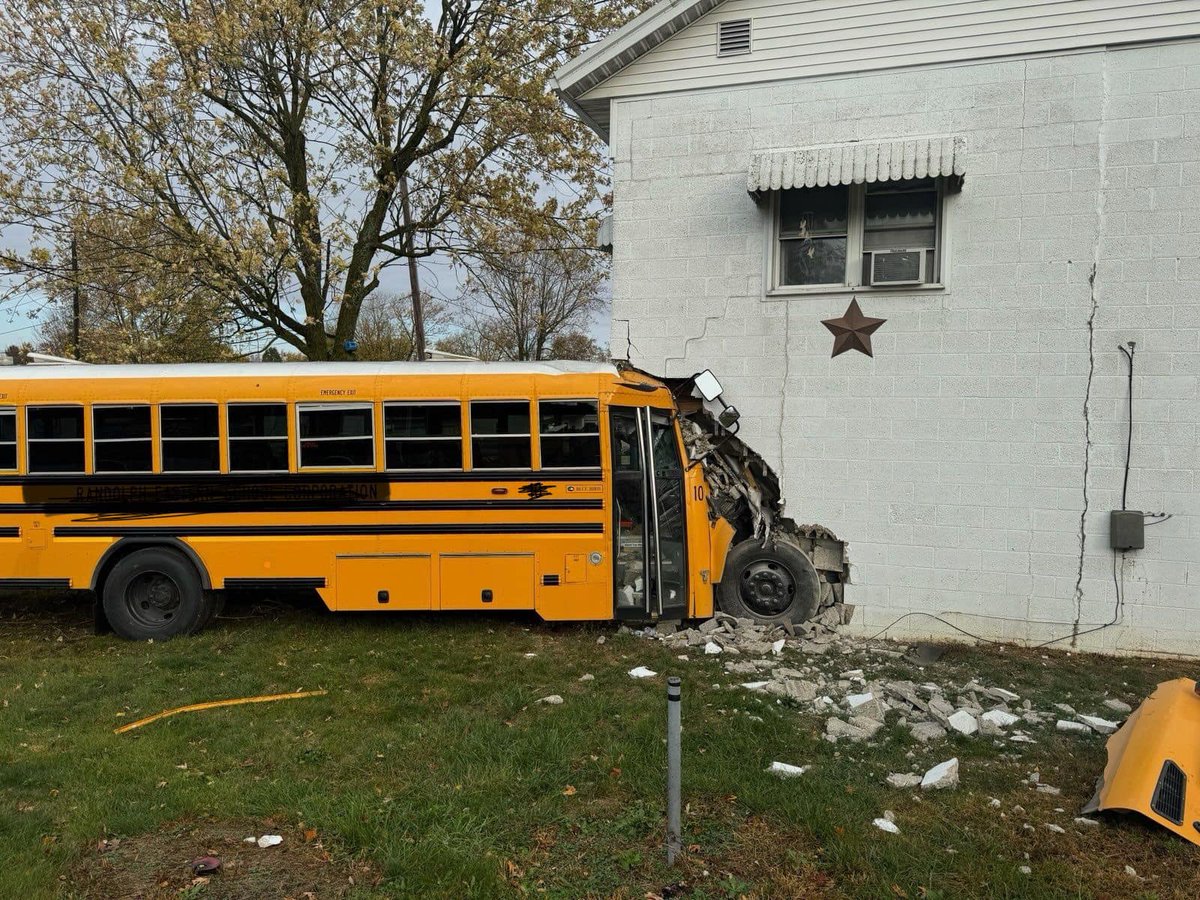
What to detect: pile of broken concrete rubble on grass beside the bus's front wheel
<box><xmin>622</xmin><ymin>619</ymin><xmax>1128</xmax><ymax>744</ymax></box>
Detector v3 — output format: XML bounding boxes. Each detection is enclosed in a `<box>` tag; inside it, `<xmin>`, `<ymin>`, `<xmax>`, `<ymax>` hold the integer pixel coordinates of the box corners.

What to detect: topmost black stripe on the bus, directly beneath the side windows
<box><xmin>0</xmin><ymin>468</ymin><xmax>604</xmax><ymax>485</ymax></box>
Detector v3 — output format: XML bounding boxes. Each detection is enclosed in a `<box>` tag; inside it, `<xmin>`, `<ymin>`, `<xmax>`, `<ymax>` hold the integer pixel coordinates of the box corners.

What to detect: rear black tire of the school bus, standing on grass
<box><xmin>103</xmin><ymin>547</ymin><xmax>214</xmax><ymax>641</ymax></box>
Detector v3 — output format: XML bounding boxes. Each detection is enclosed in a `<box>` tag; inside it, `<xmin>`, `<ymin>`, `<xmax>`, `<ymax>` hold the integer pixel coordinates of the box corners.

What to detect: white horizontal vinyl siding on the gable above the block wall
<box><xmin>582</xmin><ymin>0</ymin><xmax>1200</xmax><ymax>100</ymax></box>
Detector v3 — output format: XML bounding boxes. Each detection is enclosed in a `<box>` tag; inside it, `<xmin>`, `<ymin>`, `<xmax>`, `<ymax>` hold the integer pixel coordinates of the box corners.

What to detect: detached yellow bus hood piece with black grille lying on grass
<box><xmin>1084</xmin><ymin>678</ymin><xmax>1200</xmax><ymax>845</ymax></box>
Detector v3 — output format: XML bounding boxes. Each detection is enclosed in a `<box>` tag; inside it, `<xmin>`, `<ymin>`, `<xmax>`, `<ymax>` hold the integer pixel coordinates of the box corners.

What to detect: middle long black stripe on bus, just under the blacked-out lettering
<box><xmin>0</xmin><ymin>497</ymin><xmax>604</xmax><ymax>513</ymax></box>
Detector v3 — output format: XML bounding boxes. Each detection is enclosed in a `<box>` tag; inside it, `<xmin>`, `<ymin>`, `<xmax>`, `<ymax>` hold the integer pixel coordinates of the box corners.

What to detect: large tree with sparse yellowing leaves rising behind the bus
<box><xmin>0</xmin><ymin>0</ymin><xmax>647</xmax><ymax>360</ymax></box>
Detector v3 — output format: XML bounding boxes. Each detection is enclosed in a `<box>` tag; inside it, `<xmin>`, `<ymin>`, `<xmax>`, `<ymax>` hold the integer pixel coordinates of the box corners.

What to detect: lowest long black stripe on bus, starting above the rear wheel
<box><xmin>54</xmin><ymin>522</ymin><xmax>604</xmax><ymax>538</ymax></box>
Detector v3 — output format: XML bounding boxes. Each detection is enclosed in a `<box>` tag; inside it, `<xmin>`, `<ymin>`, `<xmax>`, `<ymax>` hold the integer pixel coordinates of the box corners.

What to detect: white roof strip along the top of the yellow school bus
<box><xmin>0</xmin><ymin>360</ymin><xmax>618</xmax><ymax>382</ymax></box>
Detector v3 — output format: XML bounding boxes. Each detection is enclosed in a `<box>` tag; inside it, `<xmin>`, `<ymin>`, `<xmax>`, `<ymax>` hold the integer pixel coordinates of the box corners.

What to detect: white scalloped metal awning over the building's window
<box><xmin>746</xmin><ymin>137</ymin><xmax>966</xmax><ymax>198</ymax></box>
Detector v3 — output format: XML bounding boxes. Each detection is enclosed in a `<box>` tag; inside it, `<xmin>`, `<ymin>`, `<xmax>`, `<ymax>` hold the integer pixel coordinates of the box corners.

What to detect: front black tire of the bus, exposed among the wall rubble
<box><xmin>716</xmin><ymin>539</ymin><xmax>821</xmax><ymax>625</ymax></box>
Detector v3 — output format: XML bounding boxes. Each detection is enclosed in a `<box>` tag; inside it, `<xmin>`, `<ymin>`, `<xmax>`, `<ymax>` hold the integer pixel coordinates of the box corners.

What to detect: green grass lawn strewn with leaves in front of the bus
<box><xmin>0</xmin><ymin>598</ymin><xmax>1200</xmax><ymax>899</ymax></box>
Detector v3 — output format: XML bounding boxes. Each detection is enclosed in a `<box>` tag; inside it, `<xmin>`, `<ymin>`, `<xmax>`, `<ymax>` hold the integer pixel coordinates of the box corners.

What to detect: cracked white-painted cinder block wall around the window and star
<box><xmin>611</xmin><ymin>42</ymin><xmax>1200</xmax><ymax>653</ymax></box>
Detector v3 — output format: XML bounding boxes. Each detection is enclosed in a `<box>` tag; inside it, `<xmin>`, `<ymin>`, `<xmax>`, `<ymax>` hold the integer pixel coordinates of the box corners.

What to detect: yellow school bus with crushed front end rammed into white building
<box><xmin>0</xmin><ymin>362</ymin><xmax>844</xmax><ymax>638</ymax></box>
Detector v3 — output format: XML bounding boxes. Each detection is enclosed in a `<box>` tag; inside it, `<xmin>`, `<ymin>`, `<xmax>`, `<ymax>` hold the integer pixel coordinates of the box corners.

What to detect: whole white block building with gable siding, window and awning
<box><xmin>558</xmin><ymin>0</ymin><xmax>1200</xmax><ymax>653</ymax></box>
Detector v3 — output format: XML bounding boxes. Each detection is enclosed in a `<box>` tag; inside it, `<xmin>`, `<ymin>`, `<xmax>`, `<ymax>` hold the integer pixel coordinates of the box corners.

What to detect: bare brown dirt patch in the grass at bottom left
<box><xmin>67</xmin><ymin>820</ymin><xmax>379</xmax><ymax>900</ymax></box>
